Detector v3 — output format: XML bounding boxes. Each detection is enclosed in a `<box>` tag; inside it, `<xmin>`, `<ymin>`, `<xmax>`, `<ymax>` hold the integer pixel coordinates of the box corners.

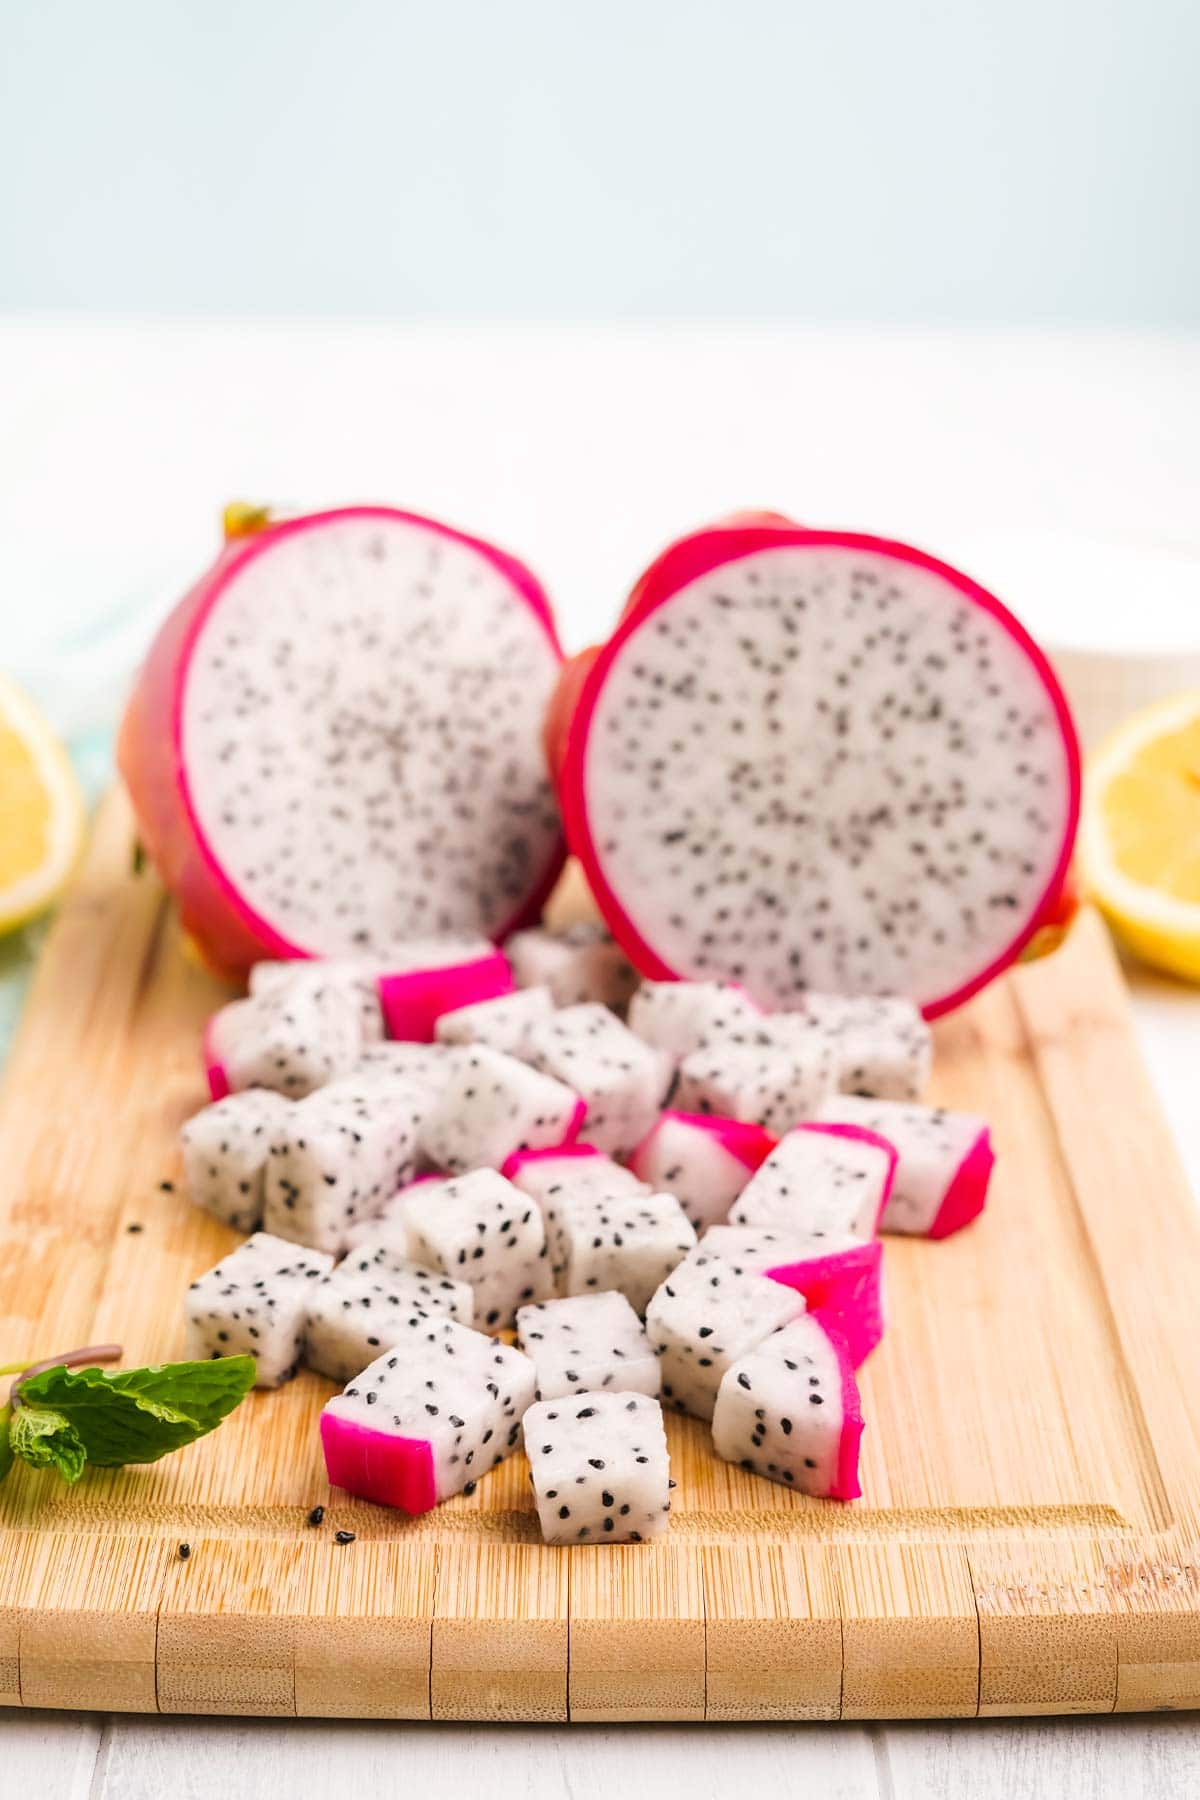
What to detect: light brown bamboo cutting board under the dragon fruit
<box><xmin>0</xmin><ymin>797</ymin><xmax>1200</xmax><ymax>1721</ymax></box>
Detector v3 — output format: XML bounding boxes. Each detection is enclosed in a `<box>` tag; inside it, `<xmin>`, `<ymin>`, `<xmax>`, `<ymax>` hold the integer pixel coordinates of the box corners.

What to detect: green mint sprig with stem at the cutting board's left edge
<box><xmin>0</xmin><ymin>1345</ymin><xmax>255</xmax><ymax>1481</ymax></box>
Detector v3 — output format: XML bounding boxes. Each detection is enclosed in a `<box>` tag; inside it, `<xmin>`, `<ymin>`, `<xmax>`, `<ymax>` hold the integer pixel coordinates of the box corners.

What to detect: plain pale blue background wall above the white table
<box><xmin>0</xmin><ymin>0</ymin><xmax>1200</xmax><ymax>324</ymax></box>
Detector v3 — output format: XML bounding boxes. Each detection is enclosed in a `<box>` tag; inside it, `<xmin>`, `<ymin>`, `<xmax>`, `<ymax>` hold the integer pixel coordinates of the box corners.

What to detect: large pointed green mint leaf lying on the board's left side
<box><xmin>13</xmin><ymin>1355</ymin><xmax>255</xmax><ymax>1480</ymax></box>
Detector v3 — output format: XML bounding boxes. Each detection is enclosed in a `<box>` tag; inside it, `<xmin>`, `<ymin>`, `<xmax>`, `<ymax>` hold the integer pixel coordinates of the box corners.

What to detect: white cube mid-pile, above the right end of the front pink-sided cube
<box><xmin>403</xmin><ymin>1168</ymin><xmax>554</xmax><ymax>1332</ymax></box>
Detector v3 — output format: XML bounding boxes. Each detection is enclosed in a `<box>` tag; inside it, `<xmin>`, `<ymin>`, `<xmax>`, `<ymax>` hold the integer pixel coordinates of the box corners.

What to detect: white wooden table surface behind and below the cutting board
<box><xmin>0</xmin><ymin>320</ymin><xmax>1200</xmax><ymax>1800</ymax></box>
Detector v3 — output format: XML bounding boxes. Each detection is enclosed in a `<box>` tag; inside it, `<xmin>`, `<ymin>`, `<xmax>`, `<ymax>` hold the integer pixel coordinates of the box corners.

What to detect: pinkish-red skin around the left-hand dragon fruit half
<box><xmin>117</xmin><ymin>506</ymin><xmax>565</xmax><ymax>977</ymax></box>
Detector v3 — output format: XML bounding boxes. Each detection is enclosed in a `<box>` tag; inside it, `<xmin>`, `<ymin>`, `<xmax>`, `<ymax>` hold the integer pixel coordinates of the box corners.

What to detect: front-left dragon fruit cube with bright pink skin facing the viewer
<box><xmin>320</xmin><ymin>1314</ymin><xmax>536</xmax><ymax>1512</ymax></box>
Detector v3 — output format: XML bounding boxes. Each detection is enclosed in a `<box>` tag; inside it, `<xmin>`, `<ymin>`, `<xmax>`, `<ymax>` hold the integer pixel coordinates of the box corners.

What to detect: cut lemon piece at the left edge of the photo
<box><xmin>0</xmin><ymin>675</ymin><xmax>86</xmax><ymax>932</ymax></box>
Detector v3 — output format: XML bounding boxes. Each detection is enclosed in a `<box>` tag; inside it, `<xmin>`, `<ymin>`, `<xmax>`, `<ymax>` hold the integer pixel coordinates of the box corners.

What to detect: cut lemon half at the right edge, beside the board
<box><xmin>1079</xmin><ymin>693</ymin><xmax>1200</xmax><ymax>981</ymax></box>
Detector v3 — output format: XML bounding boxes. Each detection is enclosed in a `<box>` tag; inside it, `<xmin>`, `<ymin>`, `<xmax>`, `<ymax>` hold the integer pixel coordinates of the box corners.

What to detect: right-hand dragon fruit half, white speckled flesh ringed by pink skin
<box><xmin>547</xmin><ymin>518</ymin><xmax>1079</xmax><ymax>1017</ymax></box>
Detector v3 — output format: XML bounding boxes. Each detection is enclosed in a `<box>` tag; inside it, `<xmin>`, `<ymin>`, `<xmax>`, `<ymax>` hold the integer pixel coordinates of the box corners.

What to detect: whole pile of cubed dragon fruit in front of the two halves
<box><xmin>182</xmin><ymin>927</ymin><xmax>993</xmax><ymax>1544</ymax></box>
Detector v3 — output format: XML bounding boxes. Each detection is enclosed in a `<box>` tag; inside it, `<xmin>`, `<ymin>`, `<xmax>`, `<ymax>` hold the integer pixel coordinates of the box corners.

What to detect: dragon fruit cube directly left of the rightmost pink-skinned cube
<box><xmin>729</xmin><ymin>1125</ymin><xmax>896</xmax><ymax>1253</ymax></box>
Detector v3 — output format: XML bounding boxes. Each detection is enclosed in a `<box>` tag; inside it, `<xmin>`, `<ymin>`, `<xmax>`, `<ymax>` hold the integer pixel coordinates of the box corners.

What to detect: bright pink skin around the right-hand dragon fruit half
<box><xmin>547</xmin><ymin>518</ymin><xmax>1081</xmax><ymax>1019</ymax></box>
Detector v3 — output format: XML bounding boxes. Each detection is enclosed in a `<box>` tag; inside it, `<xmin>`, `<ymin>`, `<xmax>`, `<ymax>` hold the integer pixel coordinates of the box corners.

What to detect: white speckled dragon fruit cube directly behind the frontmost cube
<box><xmin>516</xmin><ymin>1292</ymin><xmax>658</xmax><ymax>1400</ymax></box>
